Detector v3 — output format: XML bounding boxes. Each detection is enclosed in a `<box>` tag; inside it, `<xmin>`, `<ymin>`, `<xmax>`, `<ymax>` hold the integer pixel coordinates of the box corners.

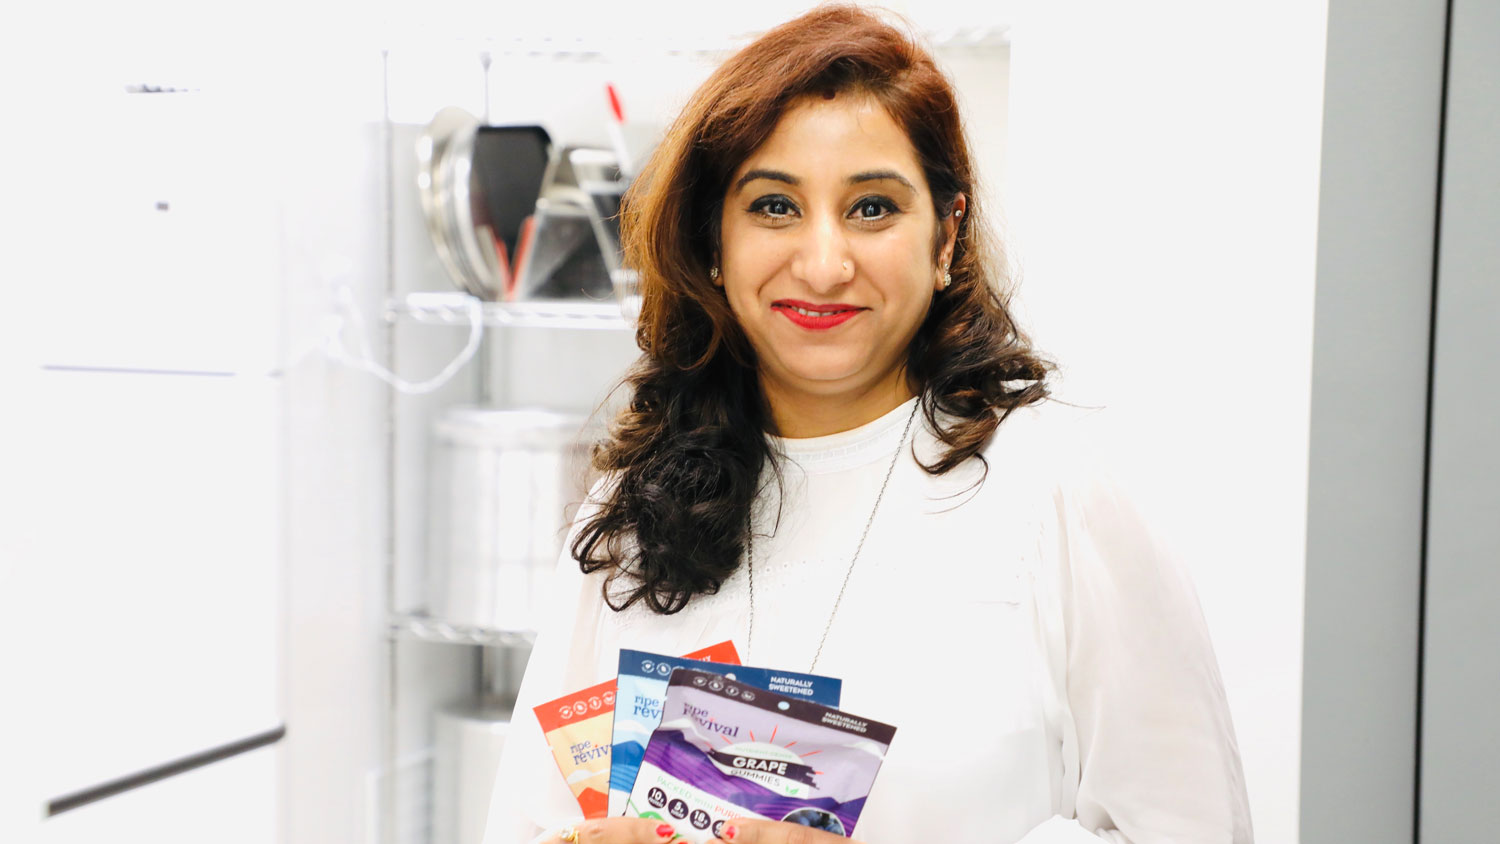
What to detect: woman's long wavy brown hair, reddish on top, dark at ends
<box><xmin>572</xmin><ymin>6</ymin><xmax>1053</xmax><ymax>613</ymax></box>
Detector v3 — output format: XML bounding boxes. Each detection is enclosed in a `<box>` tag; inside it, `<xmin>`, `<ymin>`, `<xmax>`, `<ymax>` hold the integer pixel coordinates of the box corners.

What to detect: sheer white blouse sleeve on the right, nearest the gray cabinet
<box><xmin>1020</xmin><ymin>419</ymin><xmax>1253</xmax><ymax>844</ymax></box>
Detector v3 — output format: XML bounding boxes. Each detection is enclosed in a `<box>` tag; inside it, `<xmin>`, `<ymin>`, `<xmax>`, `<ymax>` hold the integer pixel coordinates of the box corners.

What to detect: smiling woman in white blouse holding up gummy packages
<box><xmin>486</xmin><ymin>6</ymin><xmax>1251</xmax><ymax>844</ymax></box>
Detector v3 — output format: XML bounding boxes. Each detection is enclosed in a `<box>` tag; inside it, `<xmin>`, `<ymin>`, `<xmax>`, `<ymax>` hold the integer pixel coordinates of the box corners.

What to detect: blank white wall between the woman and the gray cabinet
<box><xmin>1008</xmin><ymin>0</ymin><xmax>1326</xmax><ymax>841</ymax></box>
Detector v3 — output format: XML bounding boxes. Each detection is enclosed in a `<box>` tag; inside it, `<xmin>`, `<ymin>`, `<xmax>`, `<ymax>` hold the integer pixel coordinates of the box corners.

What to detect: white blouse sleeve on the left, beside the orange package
<box><xmin>482</xmin><ymin>481</ymin><xmax>615</xmax><ymax>844</ymax></box>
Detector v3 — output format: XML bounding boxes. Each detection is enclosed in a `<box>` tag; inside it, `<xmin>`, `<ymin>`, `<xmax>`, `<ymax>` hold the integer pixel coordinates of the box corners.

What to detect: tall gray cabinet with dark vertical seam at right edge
<box><xmin>1301</xmin><ymin>0</ymin><xmax>1500</xmax><ymax>844</ymax></box>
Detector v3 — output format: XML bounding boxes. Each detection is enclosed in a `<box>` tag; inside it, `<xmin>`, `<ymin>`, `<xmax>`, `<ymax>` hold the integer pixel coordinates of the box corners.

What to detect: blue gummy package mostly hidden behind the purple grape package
<box><xmin>609</xmin><ymin>648</ymin><xmax>843</xmax><ymax>817</ymax></box>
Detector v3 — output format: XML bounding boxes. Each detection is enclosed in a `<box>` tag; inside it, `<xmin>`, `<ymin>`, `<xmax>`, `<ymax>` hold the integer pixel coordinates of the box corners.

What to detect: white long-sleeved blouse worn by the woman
<box><xmin>485</xmin><ymin>399</ymin><xmax>1251</xmax><ymax>844</ymax></box>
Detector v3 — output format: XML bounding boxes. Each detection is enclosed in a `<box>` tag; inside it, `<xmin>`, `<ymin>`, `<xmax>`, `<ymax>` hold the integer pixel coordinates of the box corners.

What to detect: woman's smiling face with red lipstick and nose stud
<box><xmin>716</xmin><ymin>94</ymin><xmax>965</xmax><ymax>402</ymax></box>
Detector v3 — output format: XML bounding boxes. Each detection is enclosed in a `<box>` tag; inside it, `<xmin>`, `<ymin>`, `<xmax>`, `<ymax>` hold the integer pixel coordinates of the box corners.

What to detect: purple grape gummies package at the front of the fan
<box><xmin>627</xmin><ymin>669</ymin><xmax>896</xmax><ymax>844</ymax></box>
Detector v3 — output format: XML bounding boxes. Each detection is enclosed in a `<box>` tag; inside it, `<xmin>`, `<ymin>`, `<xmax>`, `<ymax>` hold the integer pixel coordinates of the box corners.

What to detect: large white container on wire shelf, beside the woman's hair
<box><xmin>428</xmin><ymin>406</ymin><xmax>588</xmax><ymax>631</ymax></box>
